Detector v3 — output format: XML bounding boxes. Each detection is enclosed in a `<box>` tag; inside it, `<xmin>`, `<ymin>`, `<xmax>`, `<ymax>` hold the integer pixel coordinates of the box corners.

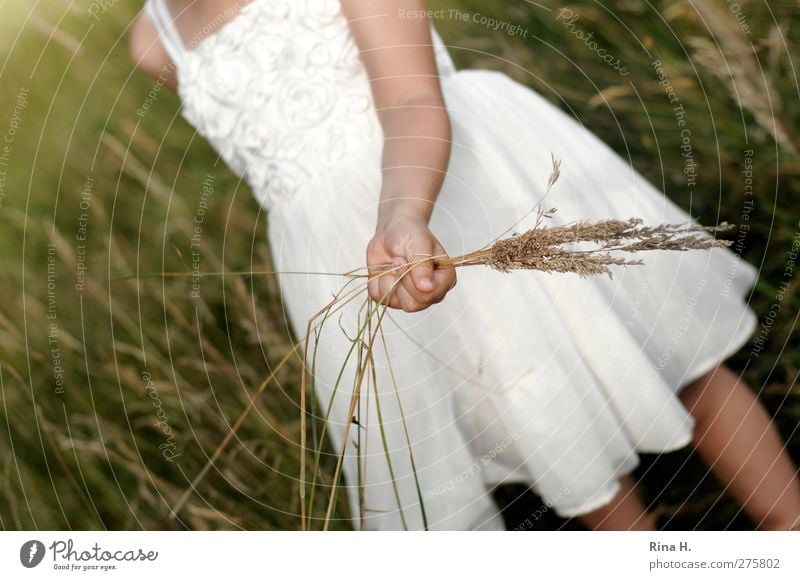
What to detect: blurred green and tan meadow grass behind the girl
<box><xmin>0</xmin><ymin>0</ymin><xmax>800</xmax><ymax>529</ymax></box>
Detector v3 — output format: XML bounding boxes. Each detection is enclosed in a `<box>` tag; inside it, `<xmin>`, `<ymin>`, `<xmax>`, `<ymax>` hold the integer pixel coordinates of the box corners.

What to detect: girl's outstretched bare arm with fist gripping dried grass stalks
<box><xmin>342</xmin><ymin>0</ymin><xmax>456</xmax><ymax>311</ymax></box>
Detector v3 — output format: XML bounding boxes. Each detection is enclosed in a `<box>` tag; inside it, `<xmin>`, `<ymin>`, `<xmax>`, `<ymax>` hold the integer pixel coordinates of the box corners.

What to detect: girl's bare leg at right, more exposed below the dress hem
<box><xmin>679</xmin><ymin>365</ymin><xmax>800</xmax><ymax>530</ymax></box>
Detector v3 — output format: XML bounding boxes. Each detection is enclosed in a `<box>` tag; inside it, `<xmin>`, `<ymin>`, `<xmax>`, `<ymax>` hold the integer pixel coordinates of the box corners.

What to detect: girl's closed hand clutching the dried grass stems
<box><xmin>367</xmin><ymin>217</ymin><xmax>456</xmax><ymax>312</ymax></box>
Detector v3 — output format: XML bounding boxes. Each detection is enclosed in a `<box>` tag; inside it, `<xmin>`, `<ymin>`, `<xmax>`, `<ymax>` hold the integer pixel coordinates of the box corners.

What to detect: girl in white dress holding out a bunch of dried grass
<box><xmin>130</xmin><ymin>0</ymin><xmax>800</xmax><ymax>530</ymax></box>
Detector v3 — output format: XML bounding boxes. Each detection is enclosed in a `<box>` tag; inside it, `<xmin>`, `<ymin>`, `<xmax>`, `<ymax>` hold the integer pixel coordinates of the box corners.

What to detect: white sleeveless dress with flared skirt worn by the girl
<box><xmin>146</xmin><ymin>0</ymin><xmax>757</xmax><ymax>530</ymax></box>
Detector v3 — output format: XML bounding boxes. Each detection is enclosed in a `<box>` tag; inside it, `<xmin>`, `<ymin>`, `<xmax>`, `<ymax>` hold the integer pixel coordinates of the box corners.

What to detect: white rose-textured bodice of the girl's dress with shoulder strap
<box><xmin>146</xmin><ymin>0</ymin><xmax>454</xmax><ymax>209</ymax></box>
